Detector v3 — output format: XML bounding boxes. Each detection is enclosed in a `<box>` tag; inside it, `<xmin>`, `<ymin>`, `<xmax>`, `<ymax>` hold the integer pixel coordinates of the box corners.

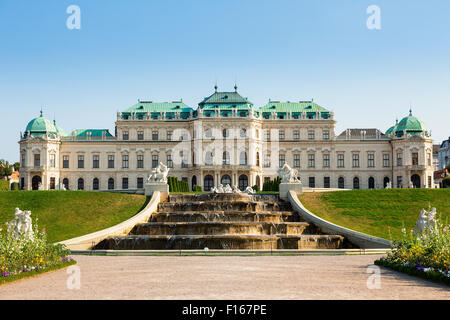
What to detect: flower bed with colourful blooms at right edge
<box><xmin>375</xmin><ymin>222</ymin><xmax>450</xmax><ymax>285</ymax></box>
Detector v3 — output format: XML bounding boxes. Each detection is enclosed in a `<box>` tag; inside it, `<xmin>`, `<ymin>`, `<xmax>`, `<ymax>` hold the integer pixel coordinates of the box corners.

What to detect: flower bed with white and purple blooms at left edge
<box><xmin>0</xmin><ymin>220</ymin><xmax>75</xmax><ymax>284</ymax></box>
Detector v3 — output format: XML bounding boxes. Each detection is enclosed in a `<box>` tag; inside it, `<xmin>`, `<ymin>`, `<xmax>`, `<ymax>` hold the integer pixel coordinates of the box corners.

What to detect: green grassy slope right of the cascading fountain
<box><xmin>299</xmin><ymin>189</ymin><xmax>450</xmax><ymax>240</ymax></box>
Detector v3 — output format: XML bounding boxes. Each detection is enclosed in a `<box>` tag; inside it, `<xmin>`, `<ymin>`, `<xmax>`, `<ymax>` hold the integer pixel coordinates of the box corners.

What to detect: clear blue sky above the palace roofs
<box><xmin>0</xmin><ymin>0</ymin><xmax>450</xmax><ymax>161</ymax></box>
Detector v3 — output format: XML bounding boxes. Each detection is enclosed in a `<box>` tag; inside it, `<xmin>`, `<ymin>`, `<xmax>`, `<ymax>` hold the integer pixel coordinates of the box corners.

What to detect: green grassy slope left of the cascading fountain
<box><xmin>0</xmin><ymin>191</ymin><xmax>146</xmax><ymax>242</ymax></box>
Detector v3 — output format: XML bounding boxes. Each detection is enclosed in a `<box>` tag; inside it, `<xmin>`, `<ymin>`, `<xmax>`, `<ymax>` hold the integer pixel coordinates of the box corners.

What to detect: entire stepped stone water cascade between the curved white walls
<box><xmin>95</xmin><ymin>194</ymin><xmax>344</xmax><ymax>250</ymax></box>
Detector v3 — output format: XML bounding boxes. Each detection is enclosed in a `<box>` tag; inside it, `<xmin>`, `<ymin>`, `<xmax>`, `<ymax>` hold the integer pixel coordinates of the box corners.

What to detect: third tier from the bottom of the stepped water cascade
<box><xmin>149</xmin><ymin>211</ymin><xmax>300</xmax><ymax>222</ymax></box>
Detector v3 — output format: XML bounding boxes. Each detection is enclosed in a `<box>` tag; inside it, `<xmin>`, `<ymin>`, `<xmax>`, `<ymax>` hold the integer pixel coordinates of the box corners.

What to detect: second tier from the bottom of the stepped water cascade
<box><xmin>130</xmin><ymin>221</ymin><xmax>309</xmax><ymax>235</ymax></box>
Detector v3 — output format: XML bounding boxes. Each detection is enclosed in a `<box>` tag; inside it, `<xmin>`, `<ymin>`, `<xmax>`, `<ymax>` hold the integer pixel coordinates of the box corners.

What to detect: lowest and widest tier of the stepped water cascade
<box><xmin>95</xmin><ymin>235</ymin><xmax>344</xmax><ymax>250</ymax></box>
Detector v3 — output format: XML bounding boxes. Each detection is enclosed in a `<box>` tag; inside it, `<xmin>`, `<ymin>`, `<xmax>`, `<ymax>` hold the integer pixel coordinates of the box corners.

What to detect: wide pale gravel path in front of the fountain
<box><xmin>0</xmin><ymin>255</ymin><xmax>450</xmax><ymax>300</ymax></box>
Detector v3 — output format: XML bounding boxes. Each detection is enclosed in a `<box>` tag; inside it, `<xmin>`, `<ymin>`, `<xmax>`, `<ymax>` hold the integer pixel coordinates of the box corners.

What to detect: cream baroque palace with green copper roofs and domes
<box><xmin>19</xmin><ymin>86</ymin><xmax>434</xmax><ymax>193</ymax></box>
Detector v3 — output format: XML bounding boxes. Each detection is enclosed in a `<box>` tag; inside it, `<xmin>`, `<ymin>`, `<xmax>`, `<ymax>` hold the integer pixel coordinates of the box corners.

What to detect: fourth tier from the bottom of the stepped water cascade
<box><xmin>158</xmin><ymin>201</ymin><xmax>292</xmax><ymax>212</ymax></box>
